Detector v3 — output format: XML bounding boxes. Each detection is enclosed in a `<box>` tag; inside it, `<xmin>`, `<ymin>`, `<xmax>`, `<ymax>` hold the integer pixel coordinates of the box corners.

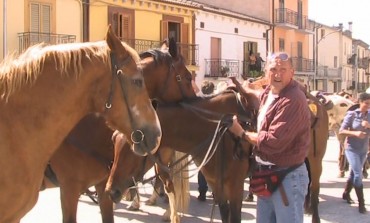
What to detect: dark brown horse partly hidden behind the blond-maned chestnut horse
<box><xmin>39</xmin><ymin>36</ymin><xmax>195</xmax><ymax>223</ymax></box>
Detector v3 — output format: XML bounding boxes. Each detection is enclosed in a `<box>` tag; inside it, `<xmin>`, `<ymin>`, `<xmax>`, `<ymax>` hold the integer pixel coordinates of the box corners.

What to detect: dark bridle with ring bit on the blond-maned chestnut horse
<box><xmin>105</xmin><ymin>52</ymin><xmax>144</xmax><ymax>144</ymax></box>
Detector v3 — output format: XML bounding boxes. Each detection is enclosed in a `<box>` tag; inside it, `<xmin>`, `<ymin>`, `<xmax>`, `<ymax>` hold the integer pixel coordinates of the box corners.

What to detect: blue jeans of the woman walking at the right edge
<box><xmin>344</xmin><ymin>149</ymin><xmax>367</xmax><ymax>187</ymax></box>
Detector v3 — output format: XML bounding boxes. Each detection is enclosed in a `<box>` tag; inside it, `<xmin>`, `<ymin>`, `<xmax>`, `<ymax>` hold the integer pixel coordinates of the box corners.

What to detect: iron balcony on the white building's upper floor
<box><xmin>204</xmin><ymin>59</ymin><xmax>239</xmax><ymax>78</ymax></box>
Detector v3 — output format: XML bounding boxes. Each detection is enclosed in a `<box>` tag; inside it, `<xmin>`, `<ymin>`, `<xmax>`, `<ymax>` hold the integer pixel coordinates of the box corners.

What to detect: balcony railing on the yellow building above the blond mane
<box><xmin>18</xmin><ymin>32</ymin><xmax>76</xmax><ymax>52</ymax></box>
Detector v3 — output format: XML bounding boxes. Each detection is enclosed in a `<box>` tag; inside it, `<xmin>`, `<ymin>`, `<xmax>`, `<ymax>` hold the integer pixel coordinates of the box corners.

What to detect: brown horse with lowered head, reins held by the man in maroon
<box><xmin>107</xmin><ymin>91</ymin><xmax>258</xmax><ymax>223</ymax></box>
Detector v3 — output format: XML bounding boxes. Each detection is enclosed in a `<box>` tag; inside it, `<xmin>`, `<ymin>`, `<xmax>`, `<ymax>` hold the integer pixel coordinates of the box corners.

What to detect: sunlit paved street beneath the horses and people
<box><xmin>21</xmin><ymin>137</ymin><xmax>370</xmax><ymax>223</ymax></box>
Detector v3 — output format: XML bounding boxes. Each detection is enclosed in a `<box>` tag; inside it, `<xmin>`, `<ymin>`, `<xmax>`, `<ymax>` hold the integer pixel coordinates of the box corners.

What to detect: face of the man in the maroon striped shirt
<box><xmin>267</xmin><ymin>57</ymin><xmax>294</xmax><ymax>94</ymax></box>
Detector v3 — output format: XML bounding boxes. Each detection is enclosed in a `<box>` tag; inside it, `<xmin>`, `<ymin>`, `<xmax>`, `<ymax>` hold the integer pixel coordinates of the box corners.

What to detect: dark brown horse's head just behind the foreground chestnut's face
<box><xmin>140</xmin><ymin>38</ymin><xmax>196</xmax><ymax>102</ymax></box>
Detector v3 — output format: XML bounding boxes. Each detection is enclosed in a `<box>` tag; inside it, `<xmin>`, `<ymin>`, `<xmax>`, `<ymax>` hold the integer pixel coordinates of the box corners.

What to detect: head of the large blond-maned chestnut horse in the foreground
<box><xmin>104</xmin><ymin>26</ymin><xmax>162</xmax><ymax>155</ymax></box>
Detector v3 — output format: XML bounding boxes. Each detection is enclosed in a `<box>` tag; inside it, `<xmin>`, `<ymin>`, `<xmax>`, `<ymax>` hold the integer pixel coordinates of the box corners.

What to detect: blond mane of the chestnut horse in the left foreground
<box><xmin>0</xmin><ymin>41</ymin><xmax>114</xmax><ymax>99</ymax></box>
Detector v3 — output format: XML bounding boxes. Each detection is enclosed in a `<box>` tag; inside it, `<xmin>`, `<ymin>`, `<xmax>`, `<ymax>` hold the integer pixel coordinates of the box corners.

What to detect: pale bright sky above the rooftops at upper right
<box><xmin>308</xmin><ymin>0</ymin><xmax>370</xmax><ymax>45</ymax></box>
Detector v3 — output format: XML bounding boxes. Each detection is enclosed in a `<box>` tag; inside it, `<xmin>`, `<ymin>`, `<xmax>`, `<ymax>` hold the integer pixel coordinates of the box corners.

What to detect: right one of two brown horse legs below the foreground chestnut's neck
<box><xmin>95</xmin><ymin>179</ymin><xmax>114</xmax><ymax>223</ymax></box>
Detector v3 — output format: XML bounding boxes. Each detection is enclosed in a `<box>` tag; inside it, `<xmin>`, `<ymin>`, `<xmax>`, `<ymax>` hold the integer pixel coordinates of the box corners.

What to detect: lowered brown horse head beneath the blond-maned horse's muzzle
<box><xmin>105</xmin><ymin>132</ymin><xmax>149</xmax><ymax>203</ymax></box>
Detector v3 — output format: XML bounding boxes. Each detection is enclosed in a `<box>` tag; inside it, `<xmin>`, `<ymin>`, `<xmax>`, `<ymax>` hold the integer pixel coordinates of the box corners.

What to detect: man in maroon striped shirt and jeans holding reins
<box><xmin>229</xmin><ymin>52</ymin><xmax>311</xmax><ymax>223</ymax></box>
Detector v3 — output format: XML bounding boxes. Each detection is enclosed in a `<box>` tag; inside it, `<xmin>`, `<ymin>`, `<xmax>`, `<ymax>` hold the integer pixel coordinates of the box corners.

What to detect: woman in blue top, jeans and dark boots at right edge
<box><xmin>339</xmin><ymin>92</ymin><xmax>370</xmax><ymax>214</ymax></box>
